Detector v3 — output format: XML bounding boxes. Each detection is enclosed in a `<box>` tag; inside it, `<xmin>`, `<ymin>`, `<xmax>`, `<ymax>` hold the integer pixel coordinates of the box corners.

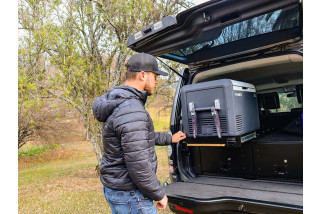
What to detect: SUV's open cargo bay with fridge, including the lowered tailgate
<box><xmin>166</xmin><ymin>54</ymin><xmax>303</xmax><ymax>214</ymax></box>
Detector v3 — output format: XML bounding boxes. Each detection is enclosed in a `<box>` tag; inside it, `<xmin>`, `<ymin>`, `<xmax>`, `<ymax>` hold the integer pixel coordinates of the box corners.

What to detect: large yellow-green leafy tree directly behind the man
<box><xmin>19</xmin><ymin>0</ymin><xmax>191</xmax><ymax>171</ymax></box>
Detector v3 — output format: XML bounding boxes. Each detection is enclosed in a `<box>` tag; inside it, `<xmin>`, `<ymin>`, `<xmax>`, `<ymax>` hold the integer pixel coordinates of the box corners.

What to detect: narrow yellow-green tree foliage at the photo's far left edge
<box><xmin>18</xmin><ymin>5</ymin><xmax>46</xmax><ymax>149</ymax></box>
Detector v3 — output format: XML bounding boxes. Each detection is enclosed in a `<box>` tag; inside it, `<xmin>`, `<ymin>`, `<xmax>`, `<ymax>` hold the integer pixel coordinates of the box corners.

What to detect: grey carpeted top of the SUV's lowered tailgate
<box><xmin>165</xmin><ymin>176</ymin><xmax>303</xmax><ymax>207</ymax></box>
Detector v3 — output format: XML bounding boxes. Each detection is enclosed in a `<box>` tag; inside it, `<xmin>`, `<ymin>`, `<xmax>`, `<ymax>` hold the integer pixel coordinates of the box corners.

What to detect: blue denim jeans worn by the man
<box><xmin>103</xmin><ymin>185</ymin><xmax>157</xmax><ymax>214</ymax></box>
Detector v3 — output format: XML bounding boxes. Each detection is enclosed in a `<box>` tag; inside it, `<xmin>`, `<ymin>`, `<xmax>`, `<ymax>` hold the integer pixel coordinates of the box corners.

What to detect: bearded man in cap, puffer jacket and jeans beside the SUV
<box><xmin>93</xmin><ymin>53</ymin><xmax>186</xmax><ymax>214</ymax></box>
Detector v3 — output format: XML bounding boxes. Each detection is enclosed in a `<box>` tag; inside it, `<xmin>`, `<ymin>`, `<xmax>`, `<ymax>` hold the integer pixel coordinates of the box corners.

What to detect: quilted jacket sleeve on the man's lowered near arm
<box><xmin>113</xmin><ymin>103</ymin><xmax>165</xmax><ymax>201</ymax></box>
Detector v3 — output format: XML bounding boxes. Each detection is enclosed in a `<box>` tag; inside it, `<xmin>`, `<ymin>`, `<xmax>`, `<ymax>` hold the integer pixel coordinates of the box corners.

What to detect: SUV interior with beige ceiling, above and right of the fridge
<box><xmin>192</xmin><ymin>54</ymin><xmax>303</xmax><ymax>141</ymax></box>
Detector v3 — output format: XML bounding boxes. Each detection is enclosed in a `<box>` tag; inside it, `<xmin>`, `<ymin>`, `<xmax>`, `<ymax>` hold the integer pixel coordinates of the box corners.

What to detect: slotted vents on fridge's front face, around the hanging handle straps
<box><xmin>189</xmin><ymin>115</ymin><xmax>227</xmax><ymax>136</ymax></box>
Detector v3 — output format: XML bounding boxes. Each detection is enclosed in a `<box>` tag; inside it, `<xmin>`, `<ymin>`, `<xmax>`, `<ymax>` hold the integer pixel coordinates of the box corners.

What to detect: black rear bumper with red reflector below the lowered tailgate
<box><xmin>168</xmin><ymin>195</ymin><xmax>303</xmax><ymax>214</ymax></box>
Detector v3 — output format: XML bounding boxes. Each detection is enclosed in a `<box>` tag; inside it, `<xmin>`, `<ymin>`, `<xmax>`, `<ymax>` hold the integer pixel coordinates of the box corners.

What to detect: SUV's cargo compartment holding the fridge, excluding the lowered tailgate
<box><xmin>181</xmin><ymin>54</ymin><xmax>303</xmax><ymax>183</ymax></box>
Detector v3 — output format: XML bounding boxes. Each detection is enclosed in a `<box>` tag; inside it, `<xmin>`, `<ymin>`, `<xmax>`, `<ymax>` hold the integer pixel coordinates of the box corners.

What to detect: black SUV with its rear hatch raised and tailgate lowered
<box><xmin>127</xmin><ymin>0</ymin><xmax>303</xmax><ymax>214</ymax></box>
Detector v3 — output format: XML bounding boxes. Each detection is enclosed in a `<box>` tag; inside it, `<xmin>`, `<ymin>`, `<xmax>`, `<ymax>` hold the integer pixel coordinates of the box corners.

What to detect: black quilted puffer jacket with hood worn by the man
<box><xmin>93</xmin><ymin>86</ymin><xmax>171</xmax><ymax>201</ymax></box>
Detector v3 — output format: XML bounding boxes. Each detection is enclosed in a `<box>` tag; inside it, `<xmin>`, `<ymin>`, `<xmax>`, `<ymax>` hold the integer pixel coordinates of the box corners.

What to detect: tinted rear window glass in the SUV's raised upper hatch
<box><xmin>170</xmin><ymin>6</ymin><xmax>300</xmax><ymax>57</ymax></box>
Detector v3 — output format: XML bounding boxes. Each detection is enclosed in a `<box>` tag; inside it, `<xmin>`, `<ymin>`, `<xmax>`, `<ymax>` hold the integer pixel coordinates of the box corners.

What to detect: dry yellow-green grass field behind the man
<box><xmin>18</xmin><ymin>108</ymin><xmax>171</xmax><ymax>214</ymax></box>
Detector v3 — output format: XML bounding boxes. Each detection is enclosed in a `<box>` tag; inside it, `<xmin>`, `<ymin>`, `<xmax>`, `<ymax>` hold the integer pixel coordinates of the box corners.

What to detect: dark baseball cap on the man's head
<box><xmin>126</xmin><ymin>53</ymin><xmax>168</xmax><ymax>76</ymax></box>
